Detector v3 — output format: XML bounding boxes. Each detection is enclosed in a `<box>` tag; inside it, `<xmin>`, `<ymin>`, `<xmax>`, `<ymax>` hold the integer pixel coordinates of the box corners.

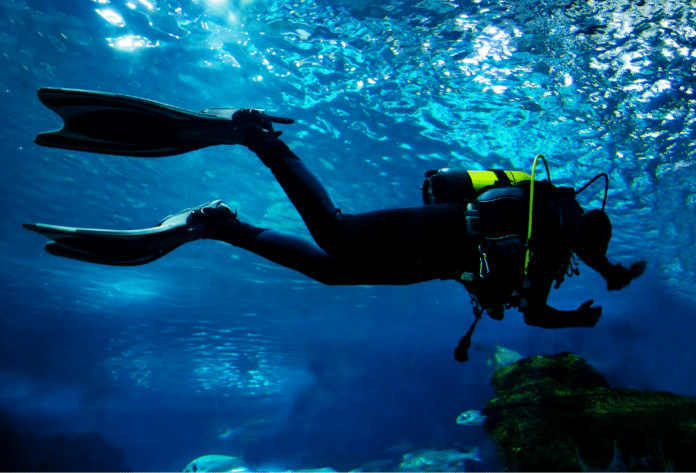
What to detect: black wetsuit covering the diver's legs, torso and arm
<box><xmin>207</xmin><ymin>129</ymin><xmax>609</xmax><ymax>328</ymax></box>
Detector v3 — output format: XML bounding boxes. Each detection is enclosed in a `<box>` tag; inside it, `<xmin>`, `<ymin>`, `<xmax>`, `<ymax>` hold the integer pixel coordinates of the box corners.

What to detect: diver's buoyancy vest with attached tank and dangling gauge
<box><xmin>422</xmin><ymin>168</ymin><xmax>532</xmax><ymax>362</ymax></box>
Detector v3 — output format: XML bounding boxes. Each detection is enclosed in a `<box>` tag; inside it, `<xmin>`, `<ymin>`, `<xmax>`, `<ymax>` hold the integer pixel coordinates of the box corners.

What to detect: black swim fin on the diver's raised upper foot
<box><xmin>34</xmin><ymin>88</ymin><xmax>294</xmax><ymax>158</ymax></box>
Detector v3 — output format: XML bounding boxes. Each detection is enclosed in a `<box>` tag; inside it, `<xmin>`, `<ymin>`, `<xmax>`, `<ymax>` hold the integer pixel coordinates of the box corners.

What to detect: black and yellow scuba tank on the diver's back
<box><xmin>422</xmin><ymin>168</ymin><xmax>532</xmax><ymax>205</ymax></box>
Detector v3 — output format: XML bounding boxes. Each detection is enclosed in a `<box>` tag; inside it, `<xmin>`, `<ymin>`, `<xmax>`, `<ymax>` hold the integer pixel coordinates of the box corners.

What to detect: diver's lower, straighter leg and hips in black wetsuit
<box><xmin>204</xmin><ymin>199</ymin><xmax>466</xmax><ymax>285</ymax></box>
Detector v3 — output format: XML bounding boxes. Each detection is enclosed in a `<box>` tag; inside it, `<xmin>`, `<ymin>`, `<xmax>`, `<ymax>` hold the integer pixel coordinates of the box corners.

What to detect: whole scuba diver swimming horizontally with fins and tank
<box><xmin>24</xmin><ymin>88</ymin><xmax>646</xmax><ymax>361</ymax></box>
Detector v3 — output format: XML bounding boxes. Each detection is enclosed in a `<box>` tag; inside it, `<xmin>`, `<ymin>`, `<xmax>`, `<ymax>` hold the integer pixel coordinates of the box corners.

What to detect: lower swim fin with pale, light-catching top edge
<box><xmin>22</xmin><ymin>200</ymin><xmax>236</xmax><ymax>266</ymax></box>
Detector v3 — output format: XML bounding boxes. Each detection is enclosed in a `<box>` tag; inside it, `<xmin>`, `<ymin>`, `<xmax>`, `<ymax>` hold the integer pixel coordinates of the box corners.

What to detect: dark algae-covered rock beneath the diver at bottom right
<box><xmin>482</xmin><ymin>352</ymin><xmax>696</xmax><ymax>471</ymax></box>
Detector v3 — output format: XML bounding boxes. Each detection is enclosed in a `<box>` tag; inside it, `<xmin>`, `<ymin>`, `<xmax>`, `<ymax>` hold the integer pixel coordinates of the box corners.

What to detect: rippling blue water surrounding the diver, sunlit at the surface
<box><xmin>0</xmin><ymin>0</ymin><xmax>696</xmax><ymax>470</ymax></box>
